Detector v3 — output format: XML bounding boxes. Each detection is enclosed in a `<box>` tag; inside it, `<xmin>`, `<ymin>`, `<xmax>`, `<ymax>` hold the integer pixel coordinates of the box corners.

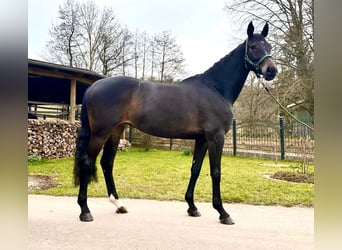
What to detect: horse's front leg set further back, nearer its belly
<box><xmin>185</xmin><ymin>139</ymin><xmax>207</xmax><ymax>217</ymax></box>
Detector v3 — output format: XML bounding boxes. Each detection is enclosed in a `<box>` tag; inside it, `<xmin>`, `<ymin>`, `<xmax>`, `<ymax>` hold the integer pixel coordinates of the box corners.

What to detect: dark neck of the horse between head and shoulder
<box><xmin>202</xmin><ymin>43</ymin><xmax>249</xmax><ymax>103</ymax></box>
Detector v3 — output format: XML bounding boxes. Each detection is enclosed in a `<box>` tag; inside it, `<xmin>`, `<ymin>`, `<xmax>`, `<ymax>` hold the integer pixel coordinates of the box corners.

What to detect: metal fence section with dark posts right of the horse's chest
<box><xmin>223</xmin><ymin>117</ymin><xmax>314</xmax><ymax>161</ymax></box>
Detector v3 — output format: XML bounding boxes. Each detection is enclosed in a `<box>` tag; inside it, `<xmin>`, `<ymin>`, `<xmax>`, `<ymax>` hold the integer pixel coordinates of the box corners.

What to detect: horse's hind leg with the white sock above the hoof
<box><xmin>101</xmin><ymin>127</ymin><xmax>127</xmax><ymax>213</ymax></box>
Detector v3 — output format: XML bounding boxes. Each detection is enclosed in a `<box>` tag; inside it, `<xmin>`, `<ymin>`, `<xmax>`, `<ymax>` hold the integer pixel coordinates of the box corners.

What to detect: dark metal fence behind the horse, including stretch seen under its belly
<box><xmin>126</xmin><ymin>117</ymin><xmax>314</xmax><ymax>162</ymax></box>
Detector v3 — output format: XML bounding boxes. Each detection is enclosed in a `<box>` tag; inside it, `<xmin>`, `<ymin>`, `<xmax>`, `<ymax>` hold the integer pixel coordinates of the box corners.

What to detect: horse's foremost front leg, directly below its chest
<box><xmin>208</xmin><ymin>135</ymin><xmax>234</xmax><ymax>225</ymax></box>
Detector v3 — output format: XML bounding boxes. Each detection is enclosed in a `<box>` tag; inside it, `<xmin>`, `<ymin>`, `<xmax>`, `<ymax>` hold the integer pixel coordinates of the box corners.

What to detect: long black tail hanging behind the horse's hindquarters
<box><xmin>73</xmin><ymin>98</ymin><xmax>97</xmax><ymax>186</ymax></box>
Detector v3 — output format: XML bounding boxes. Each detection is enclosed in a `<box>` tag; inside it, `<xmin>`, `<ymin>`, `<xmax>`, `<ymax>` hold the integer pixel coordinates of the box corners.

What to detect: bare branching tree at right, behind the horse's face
<box><xmin>225</xmin><ymin>0</ymin><xmax>314</xmax><ymax>121</ymax></box>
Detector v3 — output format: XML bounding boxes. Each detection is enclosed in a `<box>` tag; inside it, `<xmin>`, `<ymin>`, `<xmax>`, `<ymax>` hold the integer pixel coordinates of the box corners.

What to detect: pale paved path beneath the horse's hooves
<box><xmin>28</xmin><ymin>195</ymin><xmax>314</xmax><ymax>250</ymax></box>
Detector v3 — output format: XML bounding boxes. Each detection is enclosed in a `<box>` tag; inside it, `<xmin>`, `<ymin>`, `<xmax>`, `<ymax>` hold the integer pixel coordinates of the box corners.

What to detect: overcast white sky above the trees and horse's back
<box><xmin>28</xmin><ymin>0</ymin><xmax>244</xmax><ymax>75</ymax></box>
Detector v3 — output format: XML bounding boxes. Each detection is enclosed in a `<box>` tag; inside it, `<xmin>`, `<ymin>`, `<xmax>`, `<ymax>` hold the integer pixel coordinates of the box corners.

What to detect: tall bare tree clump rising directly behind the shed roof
<box><xmin>46</xmin><ymin>0</ymin><xmax>130</xmax><ymax>75</ymax></box>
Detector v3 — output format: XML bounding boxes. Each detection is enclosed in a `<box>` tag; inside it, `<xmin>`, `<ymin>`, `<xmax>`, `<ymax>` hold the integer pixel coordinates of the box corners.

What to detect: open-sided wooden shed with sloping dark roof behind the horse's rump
<box><xmin>28</xmin><ymin>59</ymin><xmax>105</xmax><ymax>122</ymax></box>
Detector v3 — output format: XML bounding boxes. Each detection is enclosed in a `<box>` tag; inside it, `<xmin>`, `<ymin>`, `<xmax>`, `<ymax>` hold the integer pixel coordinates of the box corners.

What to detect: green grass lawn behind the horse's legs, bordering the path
<box><xmin>28</xmin><ymin>148</ymin><xmax>314</xmax><ymax>206</ymax></box>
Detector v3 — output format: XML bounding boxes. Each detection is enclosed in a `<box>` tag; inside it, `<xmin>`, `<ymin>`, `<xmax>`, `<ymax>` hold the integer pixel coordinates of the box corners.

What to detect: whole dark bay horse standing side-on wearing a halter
<box><xmin>74</xmin><ymin>22</ymin><xmax>277</xmax><ymax>224</ymax></box>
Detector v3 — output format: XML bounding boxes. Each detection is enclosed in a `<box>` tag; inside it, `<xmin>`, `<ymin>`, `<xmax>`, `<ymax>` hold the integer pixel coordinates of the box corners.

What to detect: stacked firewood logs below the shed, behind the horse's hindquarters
<box><xmin>27</xmin><ymin>119</ymin><xmax>131</xmax><ymax>159</ymax></box>
